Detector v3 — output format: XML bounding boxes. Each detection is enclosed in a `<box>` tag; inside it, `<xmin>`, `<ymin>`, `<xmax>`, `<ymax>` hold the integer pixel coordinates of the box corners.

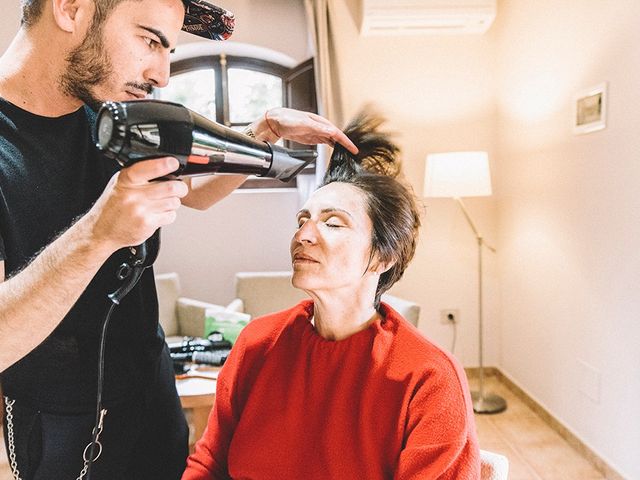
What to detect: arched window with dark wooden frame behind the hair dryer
<box><xmin>156</xmin><ymin>44</ymin><xmax>317</xmax><ymax>188</ymax></box>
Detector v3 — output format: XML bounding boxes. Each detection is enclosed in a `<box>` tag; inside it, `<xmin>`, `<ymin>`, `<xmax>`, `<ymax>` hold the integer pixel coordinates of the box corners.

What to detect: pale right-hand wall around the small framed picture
<box><xmin>496</xmin><ymin>0</ymin><xmax>640</xmax><ymax>479</ymax></box>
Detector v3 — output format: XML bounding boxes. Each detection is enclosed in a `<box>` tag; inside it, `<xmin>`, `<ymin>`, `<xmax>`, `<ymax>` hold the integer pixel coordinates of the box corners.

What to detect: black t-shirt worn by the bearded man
<box><xmin>0</xmin><ymin>99</ymin><xmax>163</xmax><ymax>413</ymax></box>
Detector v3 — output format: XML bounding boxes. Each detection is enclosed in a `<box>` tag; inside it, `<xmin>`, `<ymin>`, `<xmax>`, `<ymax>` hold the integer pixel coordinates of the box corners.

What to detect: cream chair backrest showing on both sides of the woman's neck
<box><xmin>235</xmin><ymin>272</ymin><xmax>420</xmax><ymax>326</ymax></box>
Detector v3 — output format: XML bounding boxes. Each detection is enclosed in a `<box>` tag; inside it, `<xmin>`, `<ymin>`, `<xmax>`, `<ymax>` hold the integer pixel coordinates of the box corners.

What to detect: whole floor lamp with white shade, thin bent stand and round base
<box><xmin>424</xmin><ymin>152</ymin><xmax>507</xmax><ymax>413</ymax></box>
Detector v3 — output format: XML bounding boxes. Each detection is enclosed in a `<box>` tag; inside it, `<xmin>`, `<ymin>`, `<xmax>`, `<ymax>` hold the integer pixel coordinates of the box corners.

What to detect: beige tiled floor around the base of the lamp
<box><xmin>0</xmin><ymin>377</ymin><xmax>605</xmax><ymax>480</ymax></box>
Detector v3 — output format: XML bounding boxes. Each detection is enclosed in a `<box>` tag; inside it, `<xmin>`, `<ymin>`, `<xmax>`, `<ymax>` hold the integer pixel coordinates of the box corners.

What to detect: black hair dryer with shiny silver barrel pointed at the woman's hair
<box><xmin>96</xmin><ymin>100</ymin><xmax>317</xmax><ymax>182</ymax></box>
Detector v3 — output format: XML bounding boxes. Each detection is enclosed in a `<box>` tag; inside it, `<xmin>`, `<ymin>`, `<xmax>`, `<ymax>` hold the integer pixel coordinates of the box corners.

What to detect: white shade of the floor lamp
<box><xmin>424</xmin><ymin>152</ymin><xmax>491</xmax><ymax>197</ymax></box>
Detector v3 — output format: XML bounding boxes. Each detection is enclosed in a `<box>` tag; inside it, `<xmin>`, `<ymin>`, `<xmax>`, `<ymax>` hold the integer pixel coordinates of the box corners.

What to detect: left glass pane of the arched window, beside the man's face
<box><xmin>156</xmin><ymin>68</ymin><xmax>216</xmax><ymax>121</ymax></box>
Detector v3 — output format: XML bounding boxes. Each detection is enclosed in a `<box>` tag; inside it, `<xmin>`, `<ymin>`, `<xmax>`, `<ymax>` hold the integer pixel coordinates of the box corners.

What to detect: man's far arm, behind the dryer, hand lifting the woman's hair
<box><xmin>182</xmin><ymin>108</ymin><xmax>358</xmax><ymax>210</ymax></box>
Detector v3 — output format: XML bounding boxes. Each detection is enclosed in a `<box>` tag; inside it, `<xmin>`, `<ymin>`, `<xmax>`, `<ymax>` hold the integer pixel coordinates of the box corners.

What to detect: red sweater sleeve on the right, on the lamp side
<box><xmin>395</xmin><ymin>365</ymin><xmax>480</xmax><ymax>480</ymax></box>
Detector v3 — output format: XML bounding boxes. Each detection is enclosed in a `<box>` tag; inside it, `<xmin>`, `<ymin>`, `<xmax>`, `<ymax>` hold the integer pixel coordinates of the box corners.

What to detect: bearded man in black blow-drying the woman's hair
<box><xmin>0</xmin><ymin>0</ymin><xmax>356</xmax><ymax>480</ymax></box>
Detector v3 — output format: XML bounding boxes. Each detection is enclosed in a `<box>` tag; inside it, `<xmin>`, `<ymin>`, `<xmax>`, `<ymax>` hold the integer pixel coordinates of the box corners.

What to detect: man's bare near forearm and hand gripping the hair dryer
<box><xmin>0</xmin><ymin>158</ymin><xmax>187</xmax><ymax>372</ymax></box>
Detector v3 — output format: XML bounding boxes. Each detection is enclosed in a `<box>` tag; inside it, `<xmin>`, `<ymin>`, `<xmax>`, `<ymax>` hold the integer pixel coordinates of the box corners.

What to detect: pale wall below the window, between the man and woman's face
<box><xmin>155</xmin><ymin>190</ymin><xmax>299</xmax><ymax>305</ymax></box>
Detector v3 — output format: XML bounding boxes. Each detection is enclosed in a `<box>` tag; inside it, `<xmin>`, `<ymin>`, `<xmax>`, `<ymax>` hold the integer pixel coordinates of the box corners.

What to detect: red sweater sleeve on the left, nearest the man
<box><xmin>182</xmin><ymin>335</ymin><xmax>249</xmax><ymax>480</ymax></box>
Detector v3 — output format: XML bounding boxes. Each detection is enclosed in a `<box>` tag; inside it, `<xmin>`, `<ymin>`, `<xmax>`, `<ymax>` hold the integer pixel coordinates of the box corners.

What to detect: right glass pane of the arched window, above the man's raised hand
<box><xmin>228</xmin><ymin>68</ymin><xmax>284</xmax><ymax>123</ymax></box>
